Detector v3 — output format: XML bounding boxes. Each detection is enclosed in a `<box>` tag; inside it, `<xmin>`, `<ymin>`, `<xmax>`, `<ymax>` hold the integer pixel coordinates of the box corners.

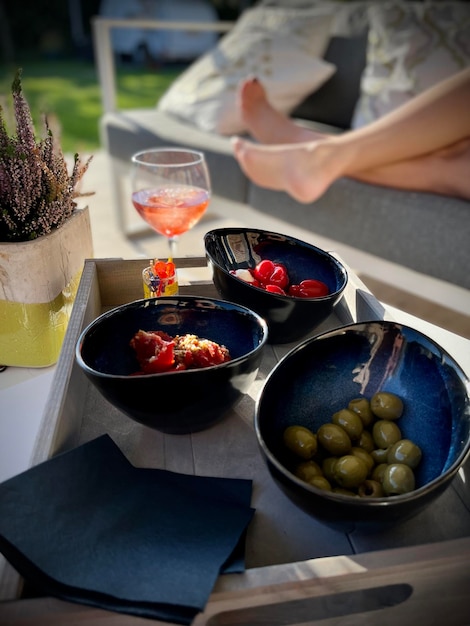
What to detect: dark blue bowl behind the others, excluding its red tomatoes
<box><xmin>204</xmin><ymin>228</ymin><xmax>348</xmax><ymax>343</ymax></box>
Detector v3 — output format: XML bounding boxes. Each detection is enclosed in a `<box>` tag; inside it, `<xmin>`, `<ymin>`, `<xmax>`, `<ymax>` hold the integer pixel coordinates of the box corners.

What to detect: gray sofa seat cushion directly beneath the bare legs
<box><xmin>249</xmin><ymin>178</ymin><xmax>470</xmax><ymax>289</ymax></box>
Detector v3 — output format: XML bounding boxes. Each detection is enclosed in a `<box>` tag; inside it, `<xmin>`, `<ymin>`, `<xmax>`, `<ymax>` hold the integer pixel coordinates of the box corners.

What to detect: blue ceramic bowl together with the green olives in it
<box><xmin>255</xmin><ymin>321</ymin><xmax>470</xmax><ymax>526</ymax></box>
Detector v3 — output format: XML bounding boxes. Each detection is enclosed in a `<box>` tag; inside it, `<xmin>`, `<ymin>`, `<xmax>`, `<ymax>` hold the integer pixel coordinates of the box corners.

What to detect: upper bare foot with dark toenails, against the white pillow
<box><xmin>238</xmin><ymin>78</ymin><xmax>323</xmax><ymax>144</ymax></box>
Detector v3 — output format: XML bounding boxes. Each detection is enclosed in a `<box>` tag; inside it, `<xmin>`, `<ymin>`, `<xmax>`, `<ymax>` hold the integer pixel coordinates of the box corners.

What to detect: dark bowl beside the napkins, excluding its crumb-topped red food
<box><xmin>76</xmin><ymin>296</ymin><xmax>268</xmax><ymax>434</ymax></box>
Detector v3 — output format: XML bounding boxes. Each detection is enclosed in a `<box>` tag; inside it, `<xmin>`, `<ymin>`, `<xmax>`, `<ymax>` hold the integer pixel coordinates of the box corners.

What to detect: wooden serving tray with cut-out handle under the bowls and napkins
<box><xmin>0</xmin><ymin>258</ymin><xmax>470</xmax><ymax>626</ymax></box>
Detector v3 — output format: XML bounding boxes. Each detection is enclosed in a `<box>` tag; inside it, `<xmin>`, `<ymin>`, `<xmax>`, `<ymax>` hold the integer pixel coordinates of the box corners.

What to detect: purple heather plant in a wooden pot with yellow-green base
<box><xmin>0</xmin><ymin>70</ymin><xmax>93</xmax><ymax>367</ymax></box>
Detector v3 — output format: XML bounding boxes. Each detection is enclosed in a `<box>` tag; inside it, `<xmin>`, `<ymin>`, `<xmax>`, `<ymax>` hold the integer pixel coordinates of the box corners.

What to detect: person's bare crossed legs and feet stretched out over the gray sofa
<box><xmin>234</xmin><ymin>70</ymin><xmax>470</xmax><ymax>202</ymax></box>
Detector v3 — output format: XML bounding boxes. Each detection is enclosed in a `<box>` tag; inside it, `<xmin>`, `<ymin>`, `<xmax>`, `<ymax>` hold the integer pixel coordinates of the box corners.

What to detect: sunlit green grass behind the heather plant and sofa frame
<box><xmin>0</xmin><ymin>60</ymin><xmax>182</xmax><ymax>153</ymax></box>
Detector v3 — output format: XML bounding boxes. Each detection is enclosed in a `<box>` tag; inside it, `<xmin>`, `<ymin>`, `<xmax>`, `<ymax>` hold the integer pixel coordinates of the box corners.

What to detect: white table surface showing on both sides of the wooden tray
<box><xmin>0</xmin><ymin>306</ymin><xmax>470</xmax><ymax>482</ymax></box>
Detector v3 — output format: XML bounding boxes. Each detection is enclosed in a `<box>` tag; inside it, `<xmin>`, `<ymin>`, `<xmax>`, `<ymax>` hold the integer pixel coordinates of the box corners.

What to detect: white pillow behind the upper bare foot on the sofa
<box><xmin>157</xmin><ymin>7</ymin><xmax>336</xmax><ymax>135</ymax></box>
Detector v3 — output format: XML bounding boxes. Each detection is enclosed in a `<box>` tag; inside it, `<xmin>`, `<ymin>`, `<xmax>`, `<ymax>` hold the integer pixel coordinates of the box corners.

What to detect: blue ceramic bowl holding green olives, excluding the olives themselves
<box><xmin>255</xmin><ymin>321</ymin><xmax>470</xmax><ymax>525</ymax></box>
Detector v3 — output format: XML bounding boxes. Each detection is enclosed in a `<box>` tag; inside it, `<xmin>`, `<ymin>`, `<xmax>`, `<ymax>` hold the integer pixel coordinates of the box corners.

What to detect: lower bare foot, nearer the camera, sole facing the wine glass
<box><xmin>232</xmin><ymin>137</ymin><xmax>341</xmax><ymax>203</ymax></box>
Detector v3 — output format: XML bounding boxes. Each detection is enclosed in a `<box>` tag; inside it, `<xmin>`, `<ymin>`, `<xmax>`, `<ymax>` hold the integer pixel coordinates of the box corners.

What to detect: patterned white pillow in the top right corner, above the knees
<box><xmin>352</xmin><ymin>1</ymin><xmax>470</xmax><ymax>128</ymax></box>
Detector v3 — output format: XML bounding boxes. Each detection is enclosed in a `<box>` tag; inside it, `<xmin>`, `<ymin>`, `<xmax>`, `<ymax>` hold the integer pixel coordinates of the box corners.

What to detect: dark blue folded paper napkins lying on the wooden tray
<box><xmin>0</xmin><ymin>435</ymin><xmax>254</xmax><ymax>624</ymax></box>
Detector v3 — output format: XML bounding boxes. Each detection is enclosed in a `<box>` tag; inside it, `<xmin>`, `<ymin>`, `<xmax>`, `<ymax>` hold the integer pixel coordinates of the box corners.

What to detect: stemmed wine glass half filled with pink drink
<box><xmin>132</xmin><ymin>148</ymin><xmax>211</xmax><ymax>259</ymax></box>
